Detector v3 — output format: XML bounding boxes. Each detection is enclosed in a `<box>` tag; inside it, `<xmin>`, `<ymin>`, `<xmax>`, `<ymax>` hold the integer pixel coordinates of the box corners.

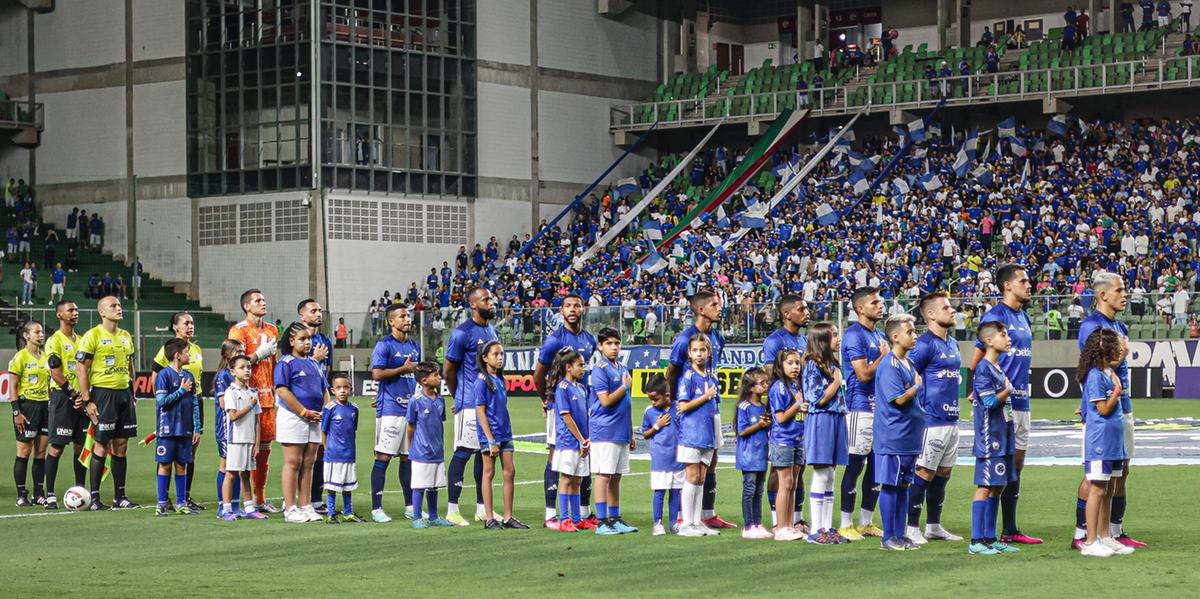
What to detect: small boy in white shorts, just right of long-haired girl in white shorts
<box><xmin>320</xmin><ymin>372</ymin><xmax>366</xmax><ymax>525</ymax></box>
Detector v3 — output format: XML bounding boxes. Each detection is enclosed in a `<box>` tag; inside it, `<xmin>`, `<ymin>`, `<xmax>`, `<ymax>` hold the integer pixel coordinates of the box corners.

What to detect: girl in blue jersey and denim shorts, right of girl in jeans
<box><xmin>767</xmin><ymin>349</ymin><xmax>808</xmax><ymax>540</ymax></box>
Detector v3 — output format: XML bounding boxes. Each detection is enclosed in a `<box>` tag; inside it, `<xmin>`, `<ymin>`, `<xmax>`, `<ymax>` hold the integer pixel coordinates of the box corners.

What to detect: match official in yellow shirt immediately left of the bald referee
<box><xmin>46</xmin><ymin>300</ymin><xmax>89</xmax><ymax>510</ymax></box>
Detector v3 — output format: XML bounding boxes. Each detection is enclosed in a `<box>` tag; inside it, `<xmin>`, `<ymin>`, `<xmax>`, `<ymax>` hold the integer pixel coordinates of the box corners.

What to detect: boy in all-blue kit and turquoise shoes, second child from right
<box><xmin>967</xmin><ymin>321</ymin><xmax>1016</xmax><ymax>556</ymax></box>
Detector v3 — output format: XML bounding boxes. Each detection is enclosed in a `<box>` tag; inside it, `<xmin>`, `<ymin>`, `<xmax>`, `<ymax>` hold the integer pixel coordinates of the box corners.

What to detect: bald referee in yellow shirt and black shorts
<box><xmin>76</xmin><ymin>295</ymin><xmax>138</xmax><ymax>511</ymax></box>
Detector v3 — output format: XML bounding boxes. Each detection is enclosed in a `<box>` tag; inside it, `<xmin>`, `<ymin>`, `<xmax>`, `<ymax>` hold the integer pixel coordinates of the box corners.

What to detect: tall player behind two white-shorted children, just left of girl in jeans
<box><xmin>667</xmin><ymin>289</ymin><xmax>737</xmax><ymax>529</ymax></box>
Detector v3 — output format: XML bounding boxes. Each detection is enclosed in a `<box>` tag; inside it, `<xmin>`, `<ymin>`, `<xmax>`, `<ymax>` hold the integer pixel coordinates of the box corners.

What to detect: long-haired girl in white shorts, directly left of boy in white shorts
<box><xmin>546</xmin><ymin>347</ymin><xmax>595</xmax><ymax>533</ymax></box>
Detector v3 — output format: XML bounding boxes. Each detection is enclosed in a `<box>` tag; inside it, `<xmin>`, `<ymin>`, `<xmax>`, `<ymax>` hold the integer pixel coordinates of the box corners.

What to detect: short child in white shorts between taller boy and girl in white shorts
<box><xmin>642</xmin><ymin>373</ymin><xmax>684</xmax><ymax>537</ymax></box>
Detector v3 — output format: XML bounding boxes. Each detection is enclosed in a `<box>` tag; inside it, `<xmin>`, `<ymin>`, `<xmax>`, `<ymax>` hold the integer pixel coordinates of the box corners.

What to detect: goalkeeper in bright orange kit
<box><xmin>227</xmin><ymin>289</ymin><xmax>283</xmax><ymax>514</ymax></box>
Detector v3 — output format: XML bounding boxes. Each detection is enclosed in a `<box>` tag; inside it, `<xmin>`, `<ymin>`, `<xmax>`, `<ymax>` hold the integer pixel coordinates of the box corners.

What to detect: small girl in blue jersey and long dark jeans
<box><xmin>737</xmin><ymin>369</ymin><xmax>775</xmax><ymax>539</ymax></box>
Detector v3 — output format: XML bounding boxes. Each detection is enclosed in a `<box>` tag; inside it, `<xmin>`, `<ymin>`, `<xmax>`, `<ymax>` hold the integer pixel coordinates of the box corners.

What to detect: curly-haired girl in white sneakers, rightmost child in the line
<box><xmin>1075</xmin><ymin>328</ymin><xmax>1134</xmax><ymax>557</ymax></box>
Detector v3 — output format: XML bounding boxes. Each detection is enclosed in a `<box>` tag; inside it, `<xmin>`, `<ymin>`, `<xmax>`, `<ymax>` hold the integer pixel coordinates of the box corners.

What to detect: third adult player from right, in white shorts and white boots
<box><xmin>905</xmin><ymin>292</ymin><xmax>962</xmax><ymax>545</ymax></box>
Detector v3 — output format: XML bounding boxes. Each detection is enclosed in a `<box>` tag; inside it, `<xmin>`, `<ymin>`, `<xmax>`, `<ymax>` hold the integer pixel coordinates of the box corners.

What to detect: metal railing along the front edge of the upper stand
<box><xmin>610</xmin><ymin>56</ymin><xmax>1200</xmax><ymax>131</ymax></box>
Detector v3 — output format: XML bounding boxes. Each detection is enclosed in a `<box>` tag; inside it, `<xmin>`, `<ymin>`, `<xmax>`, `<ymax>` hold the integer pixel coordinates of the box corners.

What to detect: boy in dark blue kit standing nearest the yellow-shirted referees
<box><xmin>154</xmin><ymin>337</ymin><xmax>200</xmax><ymax>516</ymax></box>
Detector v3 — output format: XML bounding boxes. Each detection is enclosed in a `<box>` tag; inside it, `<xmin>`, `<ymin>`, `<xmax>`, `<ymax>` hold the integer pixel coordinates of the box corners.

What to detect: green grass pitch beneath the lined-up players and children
<box><xmin>0</xmin><ymin>400</ymin><xmax>1200</xmax><ymax>597</ymax></box>
